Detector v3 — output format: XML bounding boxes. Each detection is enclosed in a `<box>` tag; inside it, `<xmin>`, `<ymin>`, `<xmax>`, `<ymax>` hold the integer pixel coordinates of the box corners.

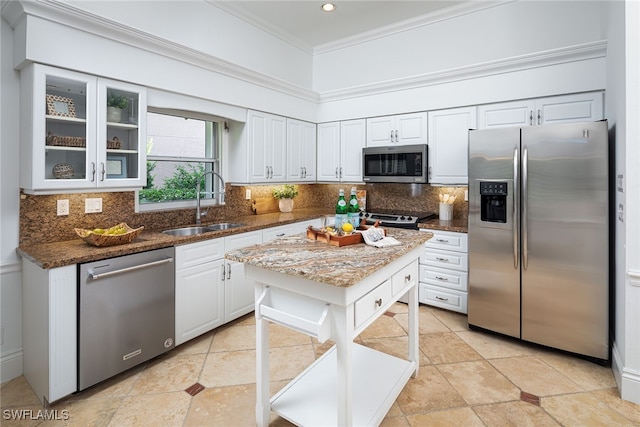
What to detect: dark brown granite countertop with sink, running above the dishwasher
<box><xmin>16</xmin><ymin>209</ymin><xmax>329</xmax><ymax>269</ymax></box>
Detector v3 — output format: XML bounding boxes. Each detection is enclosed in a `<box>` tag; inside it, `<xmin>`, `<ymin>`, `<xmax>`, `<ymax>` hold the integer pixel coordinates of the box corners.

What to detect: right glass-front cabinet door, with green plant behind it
<box><xmin>98</xmin><ymin>79</ymin><xmax>147</xmax><ymax>187</ymax></box>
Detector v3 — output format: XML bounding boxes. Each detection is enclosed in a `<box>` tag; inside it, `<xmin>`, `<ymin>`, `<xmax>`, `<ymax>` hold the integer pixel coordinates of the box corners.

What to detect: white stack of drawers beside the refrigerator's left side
<box><xmin>418</xmin><ymin>229</ymin><xmax>469</xmax><ymax>314</ymax></box>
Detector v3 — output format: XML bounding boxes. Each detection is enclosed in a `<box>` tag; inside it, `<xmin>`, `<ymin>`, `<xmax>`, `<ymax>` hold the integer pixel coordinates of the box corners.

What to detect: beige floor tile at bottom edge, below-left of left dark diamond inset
<box><xmin>109</xmin><ymin>391</ymin><xmax>191</xmax><ymax>427</ymax></box>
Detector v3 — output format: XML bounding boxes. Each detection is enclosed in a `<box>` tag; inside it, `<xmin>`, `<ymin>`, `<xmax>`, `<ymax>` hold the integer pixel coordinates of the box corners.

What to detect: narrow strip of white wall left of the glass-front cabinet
<box><xmin>0</xmin><ymin>19</ymin><xmax>22</xmax><ymax>381</ymax></box>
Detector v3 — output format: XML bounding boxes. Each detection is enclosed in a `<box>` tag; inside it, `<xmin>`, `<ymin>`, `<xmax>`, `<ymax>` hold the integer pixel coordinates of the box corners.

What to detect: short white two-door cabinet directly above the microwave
<box><xmin>367</xmin><ymin>113</ymin><xmax>427</xmax><ymax>147</ymax></box>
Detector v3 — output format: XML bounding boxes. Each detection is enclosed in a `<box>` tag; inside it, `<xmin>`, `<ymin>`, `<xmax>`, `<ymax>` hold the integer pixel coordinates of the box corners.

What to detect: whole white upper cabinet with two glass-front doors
<box><xmin>20</xmin><ymin>64</ymin><xmax>146</xmax><ymax>193</ymax></box>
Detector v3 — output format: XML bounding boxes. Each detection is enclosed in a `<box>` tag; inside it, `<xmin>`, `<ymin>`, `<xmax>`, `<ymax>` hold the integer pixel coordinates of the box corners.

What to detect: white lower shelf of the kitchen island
<box><xmin>270</xmin><ymin>344</ymin><xmax>417</xmax><ymax>426</ymax></box>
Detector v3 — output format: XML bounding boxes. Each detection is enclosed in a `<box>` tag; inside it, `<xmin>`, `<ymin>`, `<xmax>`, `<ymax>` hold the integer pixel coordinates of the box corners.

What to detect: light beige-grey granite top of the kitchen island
<box><xmin>225</xmin><ymin>228</ymin><xmax>433</xmax><ymax>287</ymax></box>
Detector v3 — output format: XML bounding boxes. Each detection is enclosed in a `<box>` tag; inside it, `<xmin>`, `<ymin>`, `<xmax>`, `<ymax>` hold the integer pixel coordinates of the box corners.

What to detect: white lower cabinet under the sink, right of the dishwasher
<box><xmin>175</xmin><ymin>231</ymin><xmax>262</xmax><ymax>345</ymax></box>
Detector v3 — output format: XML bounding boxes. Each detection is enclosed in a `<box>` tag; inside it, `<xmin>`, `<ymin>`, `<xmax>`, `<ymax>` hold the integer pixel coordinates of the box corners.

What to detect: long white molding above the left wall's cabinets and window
<box><xmin>2</xmin><ymin>0</ymin><xmax>318</xmax><ymax>103</ymax></box>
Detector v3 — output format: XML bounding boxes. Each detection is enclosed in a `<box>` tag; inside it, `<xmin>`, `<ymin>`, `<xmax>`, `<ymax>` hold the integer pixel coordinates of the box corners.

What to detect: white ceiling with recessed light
<box><xmin>211</xmin><ymin>0</ymin><xmax>470</xmax><ymax>50</ymax></box>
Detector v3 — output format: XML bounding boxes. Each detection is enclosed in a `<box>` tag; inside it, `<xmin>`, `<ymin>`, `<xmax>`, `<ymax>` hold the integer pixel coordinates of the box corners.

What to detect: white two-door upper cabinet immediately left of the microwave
<box><xmin>318</xmin><ymin>119</ymin><xmax>366</xmax><ymax>182</ymax></box>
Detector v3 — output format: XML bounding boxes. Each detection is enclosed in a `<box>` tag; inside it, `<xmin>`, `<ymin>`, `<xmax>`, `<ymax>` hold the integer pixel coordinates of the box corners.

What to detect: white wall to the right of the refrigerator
<box><xmin>606</xmin><ymin>2</ymin><xmax>640</xmax><ymax>403</ymax></box>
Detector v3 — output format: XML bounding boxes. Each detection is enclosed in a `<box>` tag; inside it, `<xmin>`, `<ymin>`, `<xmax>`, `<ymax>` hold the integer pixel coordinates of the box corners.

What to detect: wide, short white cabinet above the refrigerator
<box><xmin>478</xmin><ymin>92</ymin><xmax>604</xmax><ymax>129</ymax></box>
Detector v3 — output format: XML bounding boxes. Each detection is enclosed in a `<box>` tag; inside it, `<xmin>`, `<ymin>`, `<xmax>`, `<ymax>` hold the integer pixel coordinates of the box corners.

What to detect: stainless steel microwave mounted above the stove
<box><xmin>362</xmin><ymin>144</ymin><xmax>429</xmax><ymax>184</ymax></box>
